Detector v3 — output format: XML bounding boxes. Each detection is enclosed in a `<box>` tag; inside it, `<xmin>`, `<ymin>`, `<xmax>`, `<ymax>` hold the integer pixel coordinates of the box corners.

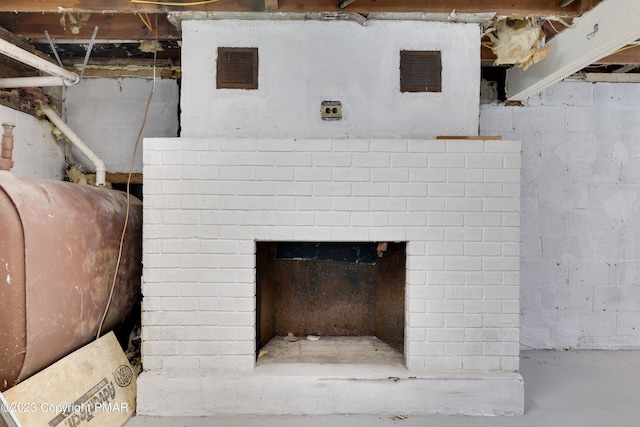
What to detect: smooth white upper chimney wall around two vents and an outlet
<box><xmin>181</xmin><ymin>20</ymin><xmax>480</xmax><ymax>139</ymax></box>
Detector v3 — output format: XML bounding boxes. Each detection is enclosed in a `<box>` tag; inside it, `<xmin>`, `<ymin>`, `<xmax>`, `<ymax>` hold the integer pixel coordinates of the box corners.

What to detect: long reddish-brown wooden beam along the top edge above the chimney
<box><xmin>0</xmin><ymin>0</ymin><xmax>578</xmax><ymax>16</ymax></box>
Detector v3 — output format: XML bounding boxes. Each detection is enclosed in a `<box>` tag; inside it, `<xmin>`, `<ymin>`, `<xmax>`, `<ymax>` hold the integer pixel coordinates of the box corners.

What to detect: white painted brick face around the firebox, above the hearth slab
<box><xmin>143</xmin><ymin>138</ymin><xmax>520</xmax><ymax>371</ymax></box>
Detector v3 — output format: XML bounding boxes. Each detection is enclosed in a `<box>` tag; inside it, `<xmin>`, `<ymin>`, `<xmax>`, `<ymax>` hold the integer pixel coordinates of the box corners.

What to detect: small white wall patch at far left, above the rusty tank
<box><xmin>0</xmin><ymin>105</ymin><xmax>65</xmax><ymax>181</ymax></box>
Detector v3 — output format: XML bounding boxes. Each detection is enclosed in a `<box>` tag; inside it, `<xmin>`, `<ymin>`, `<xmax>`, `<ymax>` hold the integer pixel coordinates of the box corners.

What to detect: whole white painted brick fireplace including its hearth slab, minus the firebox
<box><xmin>138</xmin><ymin>138</ymin><xmax>524</xmax><ymax>415</ymax></box>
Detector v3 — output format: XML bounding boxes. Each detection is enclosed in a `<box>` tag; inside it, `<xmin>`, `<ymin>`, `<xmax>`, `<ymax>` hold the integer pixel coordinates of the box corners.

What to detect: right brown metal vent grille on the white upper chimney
<box><xmin>400</xmin><ymin>50</ymin><xmax>442</xmax><ymax>92</ymax></box>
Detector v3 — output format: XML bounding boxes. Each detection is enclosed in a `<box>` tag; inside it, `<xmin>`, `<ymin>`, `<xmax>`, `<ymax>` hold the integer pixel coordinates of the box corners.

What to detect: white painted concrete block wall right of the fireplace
<box><xmin>480</xmin><ymin>81</ymin><xmax>640</xmax><ymax>349</ymax></box>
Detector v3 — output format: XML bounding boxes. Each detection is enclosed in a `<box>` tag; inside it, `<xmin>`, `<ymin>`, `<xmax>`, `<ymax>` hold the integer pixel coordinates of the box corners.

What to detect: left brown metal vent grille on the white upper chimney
<box><xmin>216</xmin><ymin>47</ymin><xmax>258</xmax><ymax>89</ymax></box>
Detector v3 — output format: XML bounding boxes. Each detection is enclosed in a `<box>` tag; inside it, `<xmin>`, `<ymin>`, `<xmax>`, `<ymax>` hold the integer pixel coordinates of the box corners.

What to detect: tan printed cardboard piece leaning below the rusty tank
<box><xmin>4</xmin><ymin>332</ymin><xmax>136</xmax><ymax>427</ymax></box>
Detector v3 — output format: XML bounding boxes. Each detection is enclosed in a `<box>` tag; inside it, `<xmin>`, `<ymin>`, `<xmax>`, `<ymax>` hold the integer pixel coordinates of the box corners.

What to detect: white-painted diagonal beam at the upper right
<box><xmin>507</xmin><ymin>0</ymin><xmax>640</xmax><ymax>100</ymax></box>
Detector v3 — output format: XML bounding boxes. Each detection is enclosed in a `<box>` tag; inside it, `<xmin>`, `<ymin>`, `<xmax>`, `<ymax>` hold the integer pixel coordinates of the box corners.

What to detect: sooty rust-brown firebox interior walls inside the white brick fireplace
<box><xmin>256</xmin><ymin>242</ymin><xmax>406</xmax><ymax>362</ymax></box>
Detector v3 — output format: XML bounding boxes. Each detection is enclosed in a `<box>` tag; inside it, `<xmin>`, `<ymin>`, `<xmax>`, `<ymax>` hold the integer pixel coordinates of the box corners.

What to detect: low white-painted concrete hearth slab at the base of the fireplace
<box><xmin>138</xmin><ymin>363</ymin><xmax>524</xmax><ymax>416</ymax></box>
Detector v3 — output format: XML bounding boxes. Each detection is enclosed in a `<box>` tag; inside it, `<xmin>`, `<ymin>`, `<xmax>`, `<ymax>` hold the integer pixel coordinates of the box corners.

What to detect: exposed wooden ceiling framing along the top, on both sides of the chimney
<box><xmin>0</xmin><ymin>0</ymin><xmax>640</xmax><ymax>102</ymax></box>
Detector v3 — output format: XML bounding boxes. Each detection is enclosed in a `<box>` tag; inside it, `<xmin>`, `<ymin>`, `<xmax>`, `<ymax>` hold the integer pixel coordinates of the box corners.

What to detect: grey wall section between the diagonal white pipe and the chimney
<box><xmin>64</xmin><ymin>78</ymin><xmax>180</xmax><ymax>172</ymax></box>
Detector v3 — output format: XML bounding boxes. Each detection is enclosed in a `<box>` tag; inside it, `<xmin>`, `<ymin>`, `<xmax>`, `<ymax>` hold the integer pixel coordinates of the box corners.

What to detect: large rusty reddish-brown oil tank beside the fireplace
<box><xmin>0</xmin><ymin>171</ymin><xmax>142</xmax><ymax>391</ymax></box>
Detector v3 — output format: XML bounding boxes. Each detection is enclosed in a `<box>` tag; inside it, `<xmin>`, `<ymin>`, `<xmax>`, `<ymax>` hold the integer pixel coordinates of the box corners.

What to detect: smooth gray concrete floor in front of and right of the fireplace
<box><xmin>126</xmin><ymin>351</ymin><xmax>640</xmax><ymax>427</ymax></box>
